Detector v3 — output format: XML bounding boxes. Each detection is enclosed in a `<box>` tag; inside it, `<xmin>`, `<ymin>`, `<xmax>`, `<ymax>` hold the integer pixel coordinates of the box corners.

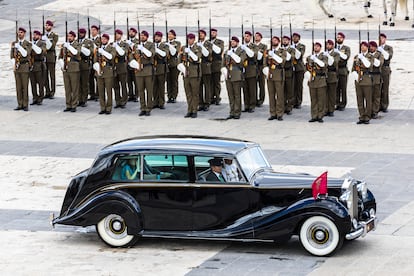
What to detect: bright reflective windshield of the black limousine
<box><xmin>237</xmin><ymin>146</ymin><xmax>271</xmax><ymax>180</ymax></box>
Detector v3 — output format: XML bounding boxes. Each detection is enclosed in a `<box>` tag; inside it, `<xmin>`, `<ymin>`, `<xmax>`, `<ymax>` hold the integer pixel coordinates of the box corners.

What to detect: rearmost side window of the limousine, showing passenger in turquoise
<box><xmin>112</xmin><ymin>155</ymin><xmax>141</xmax><ymax>181</ymax></box>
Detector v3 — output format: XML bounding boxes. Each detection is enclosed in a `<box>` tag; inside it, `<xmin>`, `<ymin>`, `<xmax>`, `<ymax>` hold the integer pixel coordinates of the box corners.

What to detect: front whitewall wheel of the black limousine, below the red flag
<box><xmin>299</xmin><ymin>216</ymin><xmax>343</xmax><ymax>256</ymax></box>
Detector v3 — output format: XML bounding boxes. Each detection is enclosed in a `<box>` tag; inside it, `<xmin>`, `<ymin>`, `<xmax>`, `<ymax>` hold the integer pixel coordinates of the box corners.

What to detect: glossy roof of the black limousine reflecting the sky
<box><xmin>100</xmin><ymin>135</ymin><xmax>257</xmax><ymax>155</ymax></box>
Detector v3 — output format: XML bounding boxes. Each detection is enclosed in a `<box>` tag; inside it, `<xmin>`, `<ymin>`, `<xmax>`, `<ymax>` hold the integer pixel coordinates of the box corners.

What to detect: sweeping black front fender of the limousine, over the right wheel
<box><xmin>253</xmin><ymin>197</ymin><xmax>351</xmax><ymax>240</ymax></box>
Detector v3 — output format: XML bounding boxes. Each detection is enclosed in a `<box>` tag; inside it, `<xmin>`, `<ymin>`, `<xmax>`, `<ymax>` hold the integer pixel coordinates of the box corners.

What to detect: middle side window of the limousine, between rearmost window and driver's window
<box><xmin>142</xmin><ymin>154</ymin><xmax>189</xmax><ymax>181</ymax></box>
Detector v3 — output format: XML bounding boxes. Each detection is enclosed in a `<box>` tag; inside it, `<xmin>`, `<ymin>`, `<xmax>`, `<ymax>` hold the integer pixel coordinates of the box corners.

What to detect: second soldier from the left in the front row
<box><xmin>58</xmin><ymin>31</ymin><xmax>81</xmax><ymax>112</ymax></box>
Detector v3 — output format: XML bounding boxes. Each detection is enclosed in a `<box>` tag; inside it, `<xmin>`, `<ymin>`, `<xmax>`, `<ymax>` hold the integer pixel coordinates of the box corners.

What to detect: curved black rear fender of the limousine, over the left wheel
<box><xmin>52</xmin><ymin>191</ymin><xmax>143</xmax><ymax>234</ymax></box>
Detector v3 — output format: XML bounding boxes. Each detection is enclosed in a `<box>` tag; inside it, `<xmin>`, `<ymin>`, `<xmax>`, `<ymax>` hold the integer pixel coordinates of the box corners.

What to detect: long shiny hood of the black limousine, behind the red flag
<box><xmin>252</xmin><ymin>171</ymin><xmax>344</xmax><ymax>189</ymax></box>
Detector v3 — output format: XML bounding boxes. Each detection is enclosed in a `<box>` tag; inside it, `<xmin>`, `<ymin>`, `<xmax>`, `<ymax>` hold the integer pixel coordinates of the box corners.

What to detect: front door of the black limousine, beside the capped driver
<box><xmin>192</xmin><ymin>156</ymin><xmax>252</xmax><ymax>237</ymax></box>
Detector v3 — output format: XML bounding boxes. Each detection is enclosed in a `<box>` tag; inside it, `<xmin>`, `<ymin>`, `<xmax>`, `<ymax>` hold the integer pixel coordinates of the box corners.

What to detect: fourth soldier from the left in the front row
<box><xmin>129</xmin><ymin>31</ymin><xmax>155</xmax><ymax>116</ymax></box>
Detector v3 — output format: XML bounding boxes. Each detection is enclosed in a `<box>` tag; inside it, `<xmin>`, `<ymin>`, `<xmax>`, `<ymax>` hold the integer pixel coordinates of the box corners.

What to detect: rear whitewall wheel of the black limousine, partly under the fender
<box><xmin>96</xmin><ymin>214</ymin><xmax>139</xmax><ymax>247</ymax></box>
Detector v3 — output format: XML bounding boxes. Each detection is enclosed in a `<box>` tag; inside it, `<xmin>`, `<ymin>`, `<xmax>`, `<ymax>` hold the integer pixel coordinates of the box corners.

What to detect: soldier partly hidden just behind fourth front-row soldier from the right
<box><xmin>241</xmin><ymin>31</ymin><xmax>258</xmax><ymax>113</ymax></box>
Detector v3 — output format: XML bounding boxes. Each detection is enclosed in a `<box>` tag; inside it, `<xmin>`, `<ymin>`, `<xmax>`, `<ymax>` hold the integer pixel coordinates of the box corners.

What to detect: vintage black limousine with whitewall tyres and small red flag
<box><xmin>52</xmin><ymin>136</ymin><xmax>377</xmax><ymax>256</ymax></box>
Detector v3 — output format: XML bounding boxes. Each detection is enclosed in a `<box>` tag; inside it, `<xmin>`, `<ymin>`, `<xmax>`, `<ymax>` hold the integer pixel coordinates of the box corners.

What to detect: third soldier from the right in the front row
<box><xmin>263</xmin><ymin>36</ymin><xmax>287</xmax><ymax>121</ymax></box>
